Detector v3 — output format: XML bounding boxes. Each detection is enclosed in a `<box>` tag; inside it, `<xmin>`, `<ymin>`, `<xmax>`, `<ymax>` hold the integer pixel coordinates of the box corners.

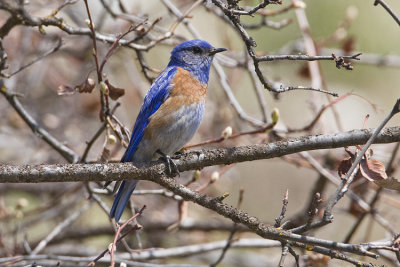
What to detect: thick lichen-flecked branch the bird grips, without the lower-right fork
<box><xmin>0</xmin><ymin>127</ymin><xmax>400</xmax><ymax>183</ymax></box>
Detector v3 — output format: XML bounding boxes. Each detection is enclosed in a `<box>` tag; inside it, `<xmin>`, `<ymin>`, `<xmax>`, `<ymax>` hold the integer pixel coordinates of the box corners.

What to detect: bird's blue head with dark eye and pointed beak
<box><xmin>168</xmin><ymin>39</ymin><xmax>226</xmax><ymax>83</ymax></box>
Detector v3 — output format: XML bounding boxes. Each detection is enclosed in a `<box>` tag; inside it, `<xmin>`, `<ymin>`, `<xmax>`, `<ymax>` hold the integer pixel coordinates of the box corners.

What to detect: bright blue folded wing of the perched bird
<box><xmin>121</xmin><ymin>67</ymin><xmax>178</xmax><ymax>162</ymax></box>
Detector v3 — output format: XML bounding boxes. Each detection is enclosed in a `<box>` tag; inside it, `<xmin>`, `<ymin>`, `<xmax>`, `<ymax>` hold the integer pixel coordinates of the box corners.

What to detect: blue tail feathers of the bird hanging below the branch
<box><xmin>110</xmin><ymin>181</ymin><xmax>138</xmax><ymax>222</ymax></box>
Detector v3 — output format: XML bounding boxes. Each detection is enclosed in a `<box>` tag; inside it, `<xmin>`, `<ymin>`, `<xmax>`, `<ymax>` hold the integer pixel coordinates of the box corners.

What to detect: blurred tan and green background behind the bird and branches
<box><xmin>0</xmin><ymin>0</ymin><xmax>400</xmax><ymax>266</ymax></box>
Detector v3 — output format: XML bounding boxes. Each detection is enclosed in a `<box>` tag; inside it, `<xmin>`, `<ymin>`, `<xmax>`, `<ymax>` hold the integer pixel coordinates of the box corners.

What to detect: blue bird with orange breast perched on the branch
<box><xmin>110</xmin><ymin>39</ymin><xmax>227</xmax><ymax>222</ymax></box>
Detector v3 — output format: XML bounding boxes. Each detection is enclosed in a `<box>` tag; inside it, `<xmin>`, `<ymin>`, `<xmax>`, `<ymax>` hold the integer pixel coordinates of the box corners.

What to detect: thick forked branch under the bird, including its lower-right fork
<box><xmin>0</xmin><ymin>127</ymin><xmax>400</xmax><ymax>257</ymax></box>
